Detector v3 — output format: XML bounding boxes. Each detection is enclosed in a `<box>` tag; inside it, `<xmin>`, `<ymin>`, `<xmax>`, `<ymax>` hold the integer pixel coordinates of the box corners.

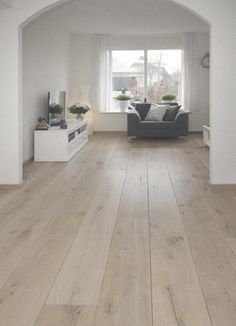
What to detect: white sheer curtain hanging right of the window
<box><xmin>182</xmin><ymin>33</ymin><xmax>199</xmax><ymax>111</ymax></box>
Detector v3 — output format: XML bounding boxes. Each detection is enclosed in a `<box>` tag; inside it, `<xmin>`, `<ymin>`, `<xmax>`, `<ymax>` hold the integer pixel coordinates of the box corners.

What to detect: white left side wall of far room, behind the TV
<box><xmin>23</xmin><ymin>16</ymin><xmax>70</xmax><ymax>161</ymax></box>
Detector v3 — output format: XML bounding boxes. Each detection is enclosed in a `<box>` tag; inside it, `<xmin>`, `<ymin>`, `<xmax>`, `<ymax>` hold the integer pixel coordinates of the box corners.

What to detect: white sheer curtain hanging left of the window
<box><xmin>91</xmin><ymin>35</ymin><xmax>112</xmax><ymax>111</ymax></box>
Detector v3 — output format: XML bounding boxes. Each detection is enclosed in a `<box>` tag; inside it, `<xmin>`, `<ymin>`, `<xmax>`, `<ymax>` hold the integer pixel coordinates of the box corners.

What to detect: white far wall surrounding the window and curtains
<box><xmin>71</xmin><ymin>33</ymin><xmax>209</xmax><ymax>131</ymax></box>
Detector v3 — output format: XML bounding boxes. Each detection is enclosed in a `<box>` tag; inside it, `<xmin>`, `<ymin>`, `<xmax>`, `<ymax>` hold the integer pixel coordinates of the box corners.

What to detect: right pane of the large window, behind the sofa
<box><xmin>147</xmin><ymin>50</ymin><xmax>182</xmax><ymax>103</ymax></box>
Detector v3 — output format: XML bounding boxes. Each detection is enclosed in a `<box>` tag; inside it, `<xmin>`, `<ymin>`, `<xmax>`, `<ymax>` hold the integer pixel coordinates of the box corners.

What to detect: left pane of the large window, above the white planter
<box><xmin>112</xmin><ymin>50</ymin><xmax>144</xmax><ymax>110</ymax></box>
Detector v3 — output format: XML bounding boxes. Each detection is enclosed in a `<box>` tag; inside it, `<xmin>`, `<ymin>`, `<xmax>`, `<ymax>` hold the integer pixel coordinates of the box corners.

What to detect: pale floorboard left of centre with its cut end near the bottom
<box><xmin>47</xmin><ymin>171</ymin><xmax>125</xmax><ymax>305</ymax></box>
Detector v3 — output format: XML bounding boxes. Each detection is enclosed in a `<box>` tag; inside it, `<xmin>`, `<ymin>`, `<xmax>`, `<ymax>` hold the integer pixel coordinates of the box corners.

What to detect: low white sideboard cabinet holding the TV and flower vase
<box><xmin>34</xmin><ymin>120</ymin><xmax>88</xmax><ymax>162</ymax></box>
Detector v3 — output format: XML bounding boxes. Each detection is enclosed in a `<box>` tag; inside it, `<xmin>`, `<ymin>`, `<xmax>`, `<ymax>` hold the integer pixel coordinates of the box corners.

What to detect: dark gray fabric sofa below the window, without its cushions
<box><xmin>127</xmin><ymin>104</ymin><xmax>188</xmax><ymax>138</ymax></box>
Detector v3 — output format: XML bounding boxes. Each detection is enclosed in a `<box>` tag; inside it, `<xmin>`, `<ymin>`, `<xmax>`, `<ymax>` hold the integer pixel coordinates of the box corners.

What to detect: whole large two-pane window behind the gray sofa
<box><xmin>111</xmin><ymin>50</ymin><xmax>182</xmax><ymax>111</ymax></box>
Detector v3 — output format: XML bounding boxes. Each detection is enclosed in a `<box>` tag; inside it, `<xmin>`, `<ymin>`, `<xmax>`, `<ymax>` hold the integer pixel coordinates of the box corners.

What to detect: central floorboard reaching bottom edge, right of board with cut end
<box><xmin>93</xmin><ymin>149</ymin><xmax>152</xmax><ymax>326</ymax></box>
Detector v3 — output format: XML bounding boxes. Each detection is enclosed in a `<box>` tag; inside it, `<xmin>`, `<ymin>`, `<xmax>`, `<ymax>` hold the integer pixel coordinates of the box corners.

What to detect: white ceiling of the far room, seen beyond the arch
<box><xmin>44</xmin><ymin>0</ymin><xmax>208</xmax><ymax>34</ymax></box>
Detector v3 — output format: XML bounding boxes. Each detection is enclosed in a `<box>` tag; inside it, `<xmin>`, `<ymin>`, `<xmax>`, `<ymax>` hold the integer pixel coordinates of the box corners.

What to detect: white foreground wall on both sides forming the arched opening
<box><xmin>0</xmin><ymin>0</ymin><xmax>236</xmax><ymax>184</ymax></box>
